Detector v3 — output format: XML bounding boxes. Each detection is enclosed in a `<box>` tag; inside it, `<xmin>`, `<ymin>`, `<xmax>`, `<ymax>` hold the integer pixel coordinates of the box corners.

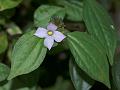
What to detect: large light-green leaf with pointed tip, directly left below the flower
<box><xmin>8</xmin><ymin>31</ymin><xmax>47</xmax><ymax>80</ymax></box>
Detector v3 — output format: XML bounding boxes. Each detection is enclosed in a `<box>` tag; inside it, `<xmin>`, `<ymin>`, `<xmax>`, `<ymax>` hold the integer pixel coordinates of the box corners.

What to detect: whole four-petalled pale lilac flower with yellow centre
<box><xmin>34</xmin><ymin>23</ymin><xmax>66</xmax><ymax>50</ymax></box>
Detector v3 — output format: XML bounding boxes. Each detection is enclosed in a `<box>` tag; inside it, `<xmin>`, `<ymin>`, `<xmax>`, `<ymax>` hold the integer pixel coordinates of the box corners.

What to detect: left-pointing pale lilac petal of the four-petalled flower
<box><xmin>34</xmin><ymin>27</ymin><xmax>47</xmax><ymax>38</ymax></box>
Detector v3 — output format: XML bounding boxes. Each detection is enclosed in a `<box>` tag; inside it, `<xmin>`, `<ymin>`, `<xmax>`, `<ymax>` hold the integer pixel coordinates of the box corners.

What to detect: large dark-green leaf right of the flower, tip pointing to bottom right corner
<box><xmin>67</xmin><ymin>32</ymin><xmax>110</xmax><ymax>88</ymax></box>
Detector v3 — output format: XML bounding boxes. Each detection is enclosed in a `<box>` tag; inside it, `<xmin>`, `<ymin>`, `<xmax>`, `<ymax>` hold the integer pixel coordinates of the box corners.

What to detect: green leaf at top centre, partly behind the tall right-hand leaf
<box><xmin>51</xmin><ymin>0</ymin><xmax>83</xmax><ymax>21</ymax></box>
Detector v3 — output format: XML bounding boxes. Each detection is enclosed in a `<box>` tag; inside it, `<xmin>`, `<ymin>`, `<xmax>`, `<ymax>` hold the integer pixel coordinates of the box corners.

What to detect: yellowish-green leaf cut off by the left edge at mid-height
<box><xmin>0</xmin><ymin>33</ymin><xmax>8</xmax><ymax>54</ymax></box>
